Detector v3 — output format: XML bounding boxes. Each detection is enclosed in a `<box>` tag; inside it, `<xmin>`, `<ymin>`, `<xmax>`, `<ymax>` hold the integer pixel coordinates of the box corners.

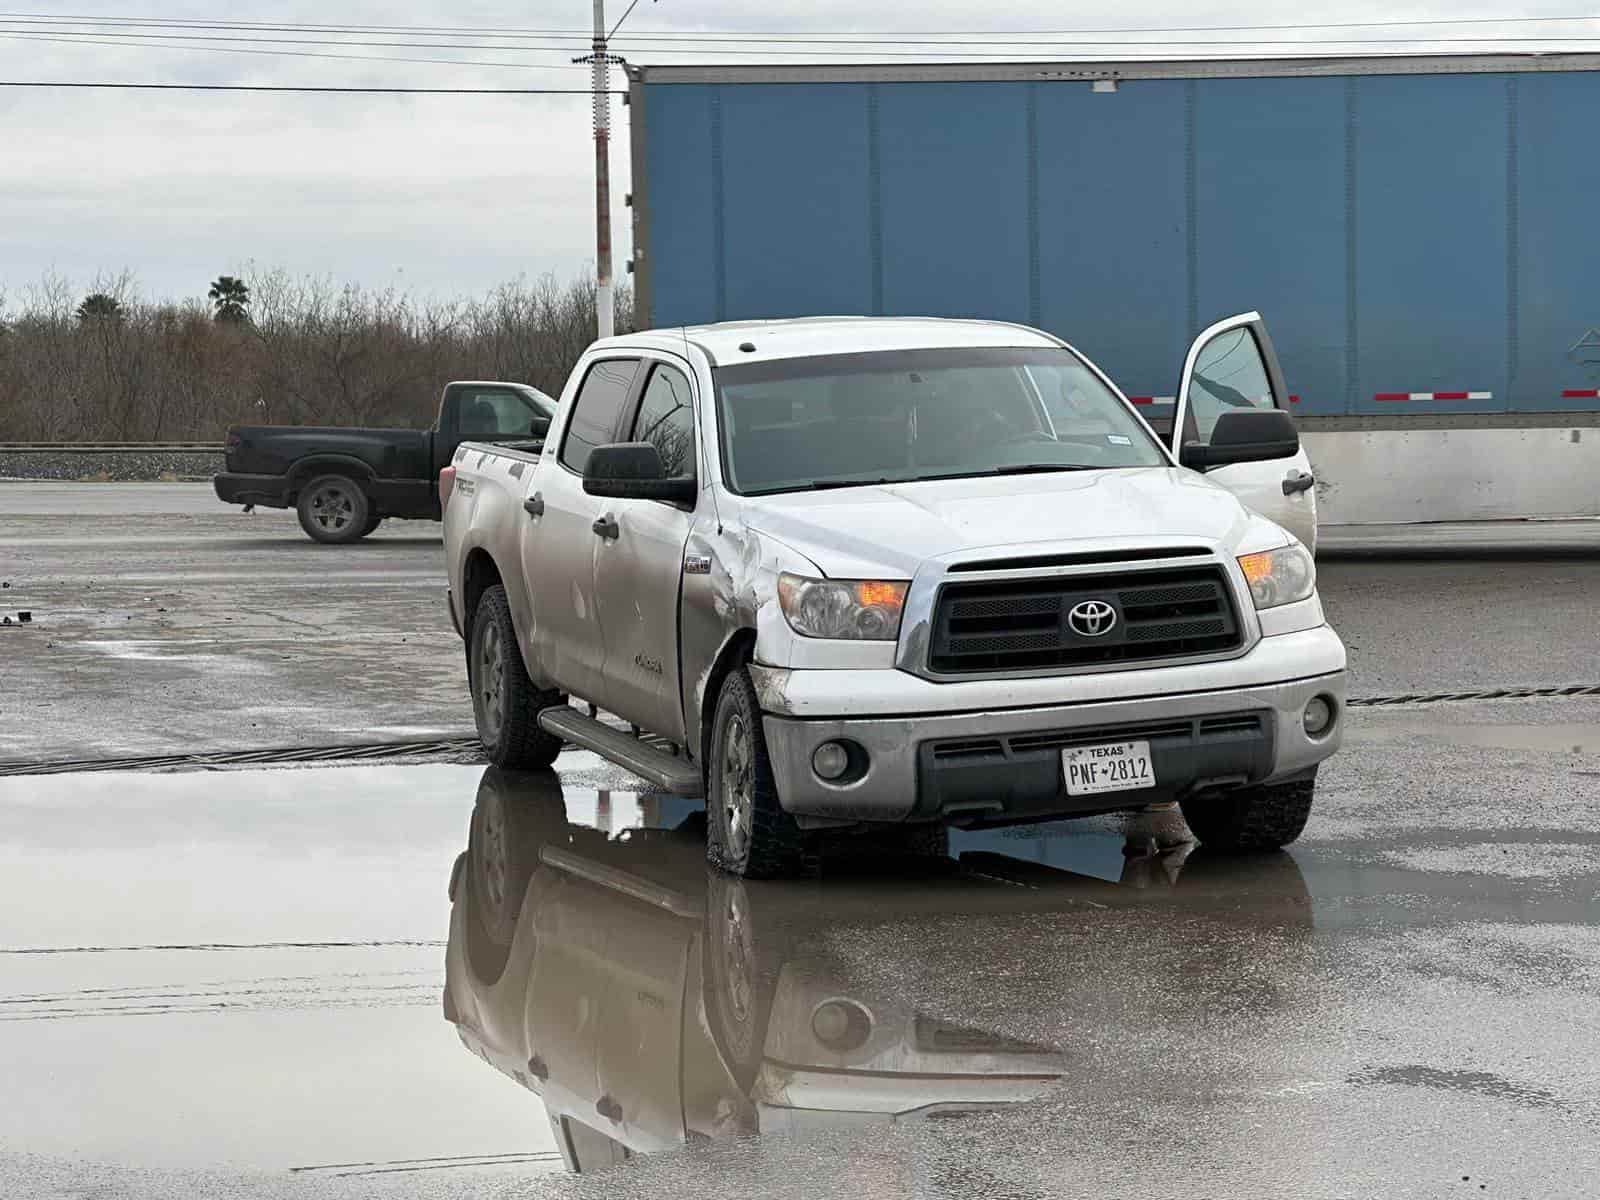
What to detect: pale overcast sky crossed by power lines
<box><xmin>0</xmin><ymin>0</ymin><xmax>1600</xmax><ymax>307</ymax></box>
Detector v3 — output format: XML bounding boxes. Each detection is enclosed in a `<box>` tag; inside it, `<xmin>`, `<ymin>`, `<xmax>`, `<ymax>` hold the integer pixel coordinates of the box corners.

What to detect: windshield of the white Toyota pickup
<box><xmin>717</xmin><ymin>349</ymin><xmax>1166</xmax><ymax>494</ymax></box>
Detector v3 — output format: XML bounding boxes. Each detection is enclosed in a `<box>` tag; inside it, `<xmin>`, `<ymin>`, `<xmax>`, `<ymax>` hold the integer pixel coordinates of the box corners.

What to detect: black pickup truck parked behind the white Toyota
<box><xmin>213</xmin><ymin>381</ymin><xmax>555</xmax><ymax>542</ymax></box>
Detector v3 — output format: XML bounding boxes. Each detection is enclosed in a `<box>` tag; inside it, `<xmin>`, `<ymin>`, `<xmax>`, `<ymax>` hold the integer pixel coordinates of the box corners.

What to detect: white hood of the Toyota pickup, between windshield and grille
<box><xmin>744</xmin><ymin>467</ymin><xmax>1290</xmax><ymax>579</ymax></box>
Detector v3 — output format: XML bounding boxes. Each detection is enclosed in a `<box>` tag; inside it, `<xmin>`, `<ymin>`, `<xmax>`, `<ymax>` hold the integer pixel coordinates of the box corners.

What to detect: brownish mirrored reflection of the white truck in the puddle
<box><xmin>445</xmin><ymin>768</ymin><xmax>1312</xmax><ymax>1171</ymax></box>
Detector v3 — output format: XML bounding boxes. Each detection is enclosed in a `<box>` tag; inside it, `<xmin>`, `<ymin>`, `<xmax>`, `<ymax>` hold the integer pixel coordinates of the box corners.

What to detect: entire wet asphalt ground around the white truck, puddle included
<box><xmin>0</xmin><ymin>485</ymin><xmax>1600</xmax><ymax>1200</ymax></box>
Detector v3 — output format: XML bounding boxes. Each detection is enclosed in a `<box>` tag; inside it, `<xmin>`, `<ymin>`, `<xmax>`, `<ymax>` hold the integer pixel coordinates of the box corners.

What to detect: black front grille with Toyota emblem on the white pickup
<box><xmin>928</xmin><ymin>565</ymin><xmax>1243</xmax><ymax>675</ymax></box>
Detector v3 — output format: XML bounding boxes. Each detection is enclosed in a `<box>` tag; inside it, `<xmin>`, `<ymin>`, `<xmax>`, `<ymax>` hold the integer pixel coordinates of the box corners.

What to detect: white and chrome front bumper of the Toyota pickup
<box><xmin>752</xmin><ymin>626</ymin><xmax>1346</xmax><ymax>824</ymax></box>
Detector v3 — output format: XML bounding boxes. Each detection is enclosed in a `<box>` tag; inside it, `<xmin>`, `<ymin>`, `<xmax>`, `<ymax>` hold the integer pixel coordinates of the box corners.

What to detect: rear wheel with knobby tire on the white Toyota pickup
<box><xmin>467</xmin><ymin>584</ymin><xmax>563</xmax><ymax>770</ymax></box>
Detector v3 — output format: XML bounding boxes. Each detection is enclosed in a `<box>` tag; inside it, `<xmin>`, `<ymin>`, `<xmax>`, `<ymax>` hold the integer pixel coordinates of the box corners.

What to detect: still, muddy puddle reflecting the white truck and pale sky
<box><xmin>0</xmin><ymin>754</ymin><xmax>1310</xmax><ymax>1178</ymax></box>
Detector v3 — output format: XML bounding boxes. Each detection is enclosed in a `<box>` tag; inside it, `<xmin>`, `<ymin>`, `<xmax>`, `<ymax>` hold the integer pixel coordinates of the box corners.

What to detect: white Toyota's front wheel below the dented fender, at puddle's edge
<box><xmin>706</xmin><ymin>667</ymin><xmax>816</xmax><ymax>878</ymax></box>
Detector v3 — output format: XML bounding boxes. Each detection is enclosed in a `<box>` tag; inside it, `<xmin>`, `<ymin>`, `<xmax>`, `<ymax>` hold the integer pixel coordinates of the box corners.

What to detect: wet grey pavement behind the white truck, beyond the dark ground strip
<box><xmin>0</xmin><ymin>483</ymin><xmax>1600</xmax><ymax>760</ymax></box>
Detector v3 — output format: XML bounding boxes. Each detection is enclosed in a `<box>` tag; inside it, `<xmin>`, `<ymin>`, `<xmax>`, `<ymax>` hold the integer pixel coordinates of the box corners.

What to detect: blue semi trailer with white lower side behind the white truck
<box><xmin>629</xmin><ymin>54</ymin><xmax>1600</xmax><ymax>522</ymax></box>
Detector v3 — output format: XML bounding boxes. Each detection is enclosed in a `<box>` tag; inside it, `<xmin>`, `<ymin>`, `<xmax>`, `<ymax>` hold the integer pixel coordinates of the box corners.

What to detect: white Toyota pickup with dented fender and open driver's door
<box><xmin>440</xmin><ymin>314</ymin><xmax>1346</xmax><ymax>877</ymax></box>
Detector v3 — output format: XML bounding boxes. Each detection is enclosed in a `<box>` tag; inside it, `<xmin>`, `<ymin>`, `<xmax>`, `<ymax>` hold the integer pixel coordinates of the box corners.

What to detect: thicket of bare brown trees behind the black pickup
<box><xmin>0</xmin><ymin>270</ymin><xmax>627</xmax><ymax>442</ymax></box>
